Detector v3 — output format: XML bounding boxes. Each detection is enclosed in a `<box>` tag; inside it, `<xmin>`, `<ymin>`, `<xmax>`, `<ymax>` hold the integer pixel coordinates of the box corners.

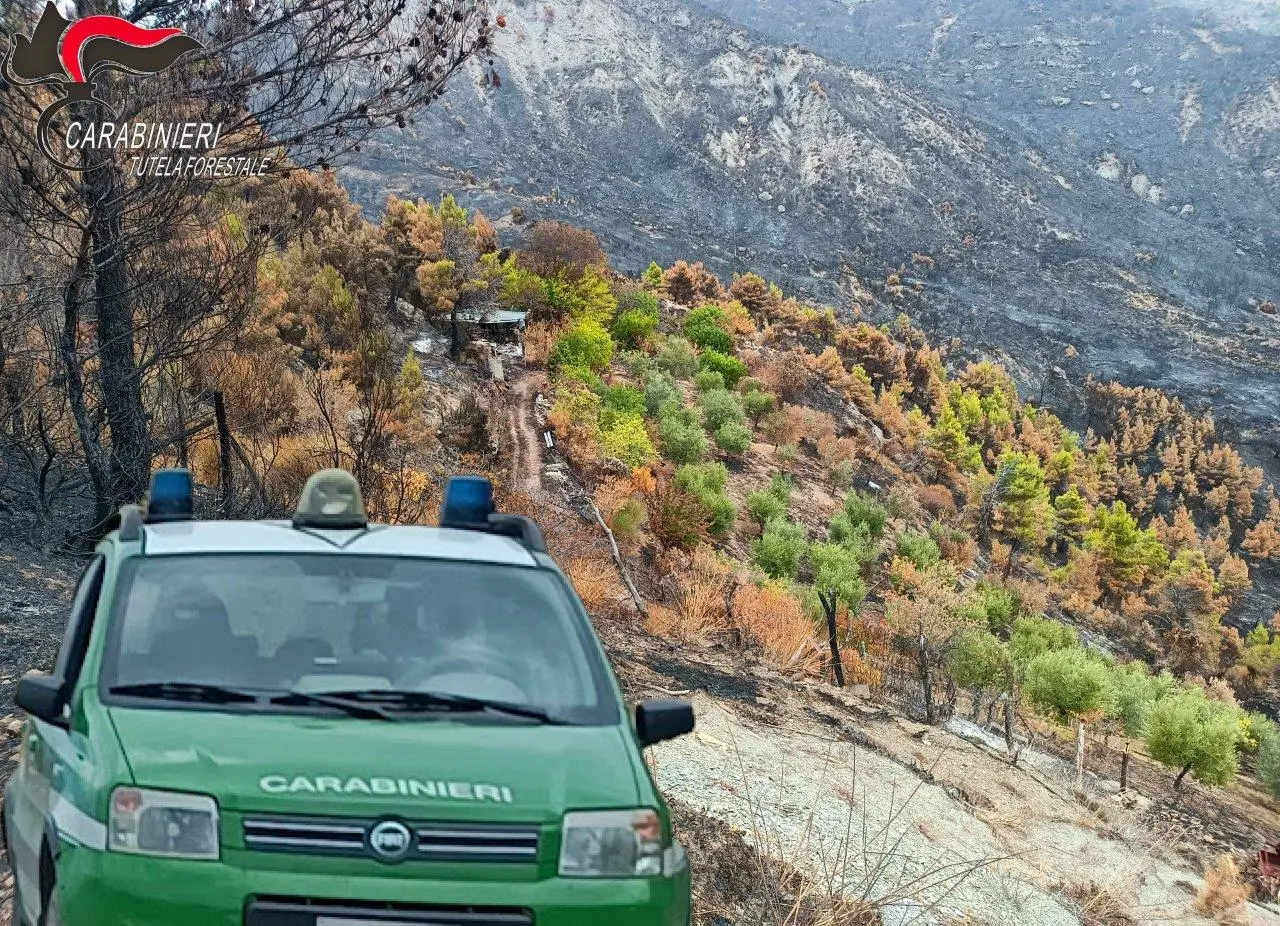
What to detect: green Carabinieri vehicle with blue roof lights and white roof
<box><xmin>3</xmin><ymin>470</ymin><xmax>694</xmax><ymax>926</ymax></box>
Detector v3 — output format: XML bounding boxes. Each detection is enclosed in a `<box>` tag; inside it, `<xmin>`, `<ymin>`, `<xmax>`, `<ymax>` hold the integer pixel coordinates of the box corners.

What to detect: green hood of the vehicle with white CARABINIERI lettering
<box><xmin>110</xmin><ymin>707</ymin><xmax>640</xmax><ymax>822</ymax></box>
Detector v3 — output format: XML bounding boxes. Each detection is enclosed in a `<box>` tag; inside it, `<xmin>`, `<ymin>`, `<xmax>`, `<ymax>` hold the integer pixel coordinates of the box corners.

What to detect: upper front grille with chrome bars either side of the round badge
<box><xmin>244</xmin><ymin>816</ymin><xmax>539</xmax><ymax>863</ymax></box>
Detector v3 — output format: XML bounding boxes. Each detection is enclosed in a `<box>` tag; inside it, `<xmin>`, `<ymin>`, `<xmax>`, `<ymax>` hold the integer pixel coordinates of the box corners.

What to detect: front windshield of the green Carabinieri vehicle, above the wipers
<box><xmin>102</xmin><ymin>553</ymin><xmax>617</xmax><ymax>724</ymax></box>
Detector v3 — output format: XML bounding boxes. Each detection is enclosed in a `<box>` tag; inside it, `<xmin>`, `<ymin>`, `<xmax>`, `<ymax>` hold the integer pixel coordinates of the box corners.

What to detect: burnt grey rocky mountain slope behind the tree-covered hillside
<box><xmin>346</xmin><ymin>0</ymin><xmax>1280</xmax><ymax>484</ymax></box>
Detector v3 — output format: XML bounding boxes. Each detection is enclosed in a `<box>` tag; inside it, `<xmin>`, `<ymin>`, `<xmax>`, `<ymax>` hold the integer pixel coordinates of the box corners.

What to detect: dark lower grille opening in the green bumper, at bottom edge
<box><xmin>244</xmin><ymin>897</ymin><xmax>534</xmax><ymax>926</ymax></box>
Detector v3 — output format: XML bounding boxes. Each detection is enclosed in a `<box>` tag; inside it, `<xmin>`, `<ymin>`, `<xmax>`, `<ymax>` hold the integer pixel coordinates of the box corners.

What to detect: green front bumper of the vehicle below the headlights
<box><xmin>58</xmin><ymin>847</ymin><xmax>690</xmax><ymax>926</ymax></box>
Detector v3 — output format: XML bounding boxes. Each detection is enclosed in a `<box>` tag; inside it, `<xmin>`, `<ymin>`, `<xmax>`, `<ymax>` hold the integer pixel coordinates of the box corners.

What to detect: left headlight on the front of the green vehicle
<box><xmin>108</xmin><ymin>788</ymin><xmax>219</xmax><ymax>859</ymax></box>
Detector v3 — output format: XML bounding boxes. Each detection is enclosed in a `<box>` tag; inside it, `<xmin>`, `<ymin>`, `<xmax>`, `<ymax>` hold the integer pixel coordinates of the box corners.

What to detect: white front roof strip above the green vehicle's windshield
<box><xmin>133</xmin><ymin>521</ymin><xmax>538</xmax><ymax>566</ymax></box>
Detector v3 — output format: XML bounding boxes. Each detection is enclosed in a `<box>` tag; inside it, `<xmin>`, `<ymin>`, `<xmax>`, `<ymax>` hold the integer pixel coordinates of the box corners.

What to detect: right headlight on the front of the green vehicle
<box><xmin>559</xmin><ymin>809</ymin><xmax>668</xmax><ymax>877</ymax></box>
